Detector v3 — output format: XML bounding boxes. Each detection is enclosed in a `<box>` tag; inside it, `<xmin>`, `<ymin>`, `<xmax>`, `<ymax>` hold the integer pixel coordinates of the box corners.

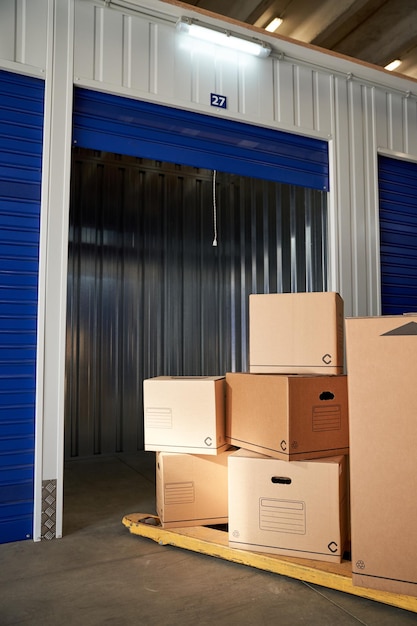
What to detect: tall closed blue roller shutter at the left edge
<box><xmin>0</xmin><ymin>67</ymin><xmax>44</xmax><ymax>542</ymax></box>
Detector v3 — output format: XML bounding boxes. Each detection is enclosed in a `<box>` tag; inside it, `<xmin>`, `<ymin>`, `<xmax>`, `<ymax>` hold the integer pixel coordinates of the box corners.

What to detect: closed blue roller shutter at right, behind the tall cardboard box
<box><xmin>379</xmin><ymin>156</ymin><xmax>417</xmax><ymax>315</ymax></box>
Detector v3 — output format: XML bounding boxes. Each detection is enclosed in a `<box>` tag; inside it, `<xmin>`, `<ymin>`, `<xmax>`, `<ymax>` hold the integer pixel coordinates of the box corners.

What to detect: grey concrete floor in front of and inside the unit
<box><xmin>0</xmin><ymin>452</ymin><xmax>417</xmax><ymax>626</ymax></box>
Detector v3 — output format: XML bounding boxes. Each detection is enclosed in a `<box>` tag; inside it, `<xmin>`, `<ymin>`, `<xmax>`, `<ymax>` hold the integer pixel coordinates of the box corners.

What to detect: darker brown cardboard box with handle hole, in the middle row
<box><xmin>226</xmin><ymin>373</ymin><xmax>349</xmax><ymax>461</ymax></box>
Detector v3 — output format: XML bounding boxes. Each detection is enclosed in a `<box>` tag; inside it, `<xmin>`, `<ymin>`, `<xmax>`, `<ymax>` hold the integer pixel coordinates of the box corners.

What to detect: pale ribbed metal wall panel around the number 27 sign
<box><xmin>74</xmin><ymin>0</ymin><xmax>333</xmax><ymax>134</ymax></box>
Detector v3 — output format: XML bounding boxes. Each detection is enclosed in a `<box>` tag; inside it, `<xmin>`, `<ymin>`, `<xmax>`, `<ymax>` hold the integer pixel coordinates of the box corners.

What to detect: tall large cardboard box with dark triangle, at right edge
<box><xmin>346</xmin><ymin>316</ymin><xmax>417</xmax><ymax>596</ymax></box>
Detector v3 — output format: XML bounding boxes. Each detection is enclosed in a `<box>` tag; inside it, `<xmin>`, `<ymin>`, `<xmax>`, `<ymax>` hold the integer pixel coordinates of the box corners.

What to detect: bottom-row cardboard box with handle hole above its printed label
<box><xmin>229</xmin><ymin>450</ymin><xmax>347</xmax><ymax>563</ymax></box>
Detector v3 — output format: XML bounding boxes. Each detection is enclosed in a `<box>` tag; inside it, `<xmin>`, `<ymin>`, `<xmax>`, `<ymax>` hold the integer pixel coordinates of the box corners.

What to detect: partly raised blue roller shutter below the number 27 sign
<box><xmin>73</xmin><ymin>88</ymin><xmax>329</xmax><ymax>191</ymax></box>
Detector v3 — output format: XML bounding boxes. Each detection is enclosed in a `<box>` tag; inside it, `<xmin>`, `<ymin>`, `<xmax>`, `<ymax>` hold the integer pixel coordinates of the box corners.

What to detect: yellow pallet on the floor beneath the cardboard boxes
<box><xmin>122</xmin><ymin>513</ymin><xmax>417</xmax><ymax>613</ymax></box>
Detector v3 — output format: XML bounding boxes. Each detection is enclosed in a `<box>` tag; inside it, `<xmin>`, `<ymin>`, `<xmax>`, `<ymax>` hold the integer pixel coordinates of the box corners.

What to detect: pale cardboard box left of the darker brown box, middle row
<box><xmin>143</xmin><ymin>376</ymin><xmax>229</xmax><ymax>455</ymax></box>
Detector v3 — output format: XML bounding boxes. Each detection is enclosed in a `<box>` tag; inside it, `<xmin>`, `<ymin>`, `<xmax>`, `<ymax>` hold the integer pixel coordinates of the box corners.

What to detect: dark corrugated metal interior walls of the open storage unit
<box><xmin>65</xmin><ymin>149</ymin><xmax>327</xmax><ymax>458</ymax></box>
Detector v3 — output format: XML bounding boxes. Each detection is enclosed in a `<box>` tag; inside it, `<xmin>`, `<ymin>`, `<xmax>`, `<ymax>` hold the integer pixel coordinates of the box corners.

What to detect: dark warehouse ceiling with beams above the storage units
<box><xmin>180</xmin><ymin>0</ymin><xmax>417</xmax><ymax>79</ymax></box>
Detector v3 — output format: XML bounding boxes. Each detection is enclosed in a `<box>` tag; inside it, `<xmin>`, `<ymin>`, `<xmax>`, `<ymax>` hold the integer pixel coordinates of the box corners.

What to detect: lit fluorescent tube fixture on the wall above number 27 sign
<box><xmin>177</xmin><ymin>17</ymin><xmax>271</xmax><ymax>57</ymax></box>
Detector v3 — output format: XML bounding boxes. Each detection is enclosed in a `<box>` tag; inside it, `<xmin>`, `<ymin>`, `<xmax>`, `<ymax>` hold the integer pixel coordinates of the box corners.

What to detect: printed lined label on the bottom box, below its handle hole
<box><xmin>259</xmin><ymin>498</ymin><xmax>306</xmax><ymax>535</ymax></box>
